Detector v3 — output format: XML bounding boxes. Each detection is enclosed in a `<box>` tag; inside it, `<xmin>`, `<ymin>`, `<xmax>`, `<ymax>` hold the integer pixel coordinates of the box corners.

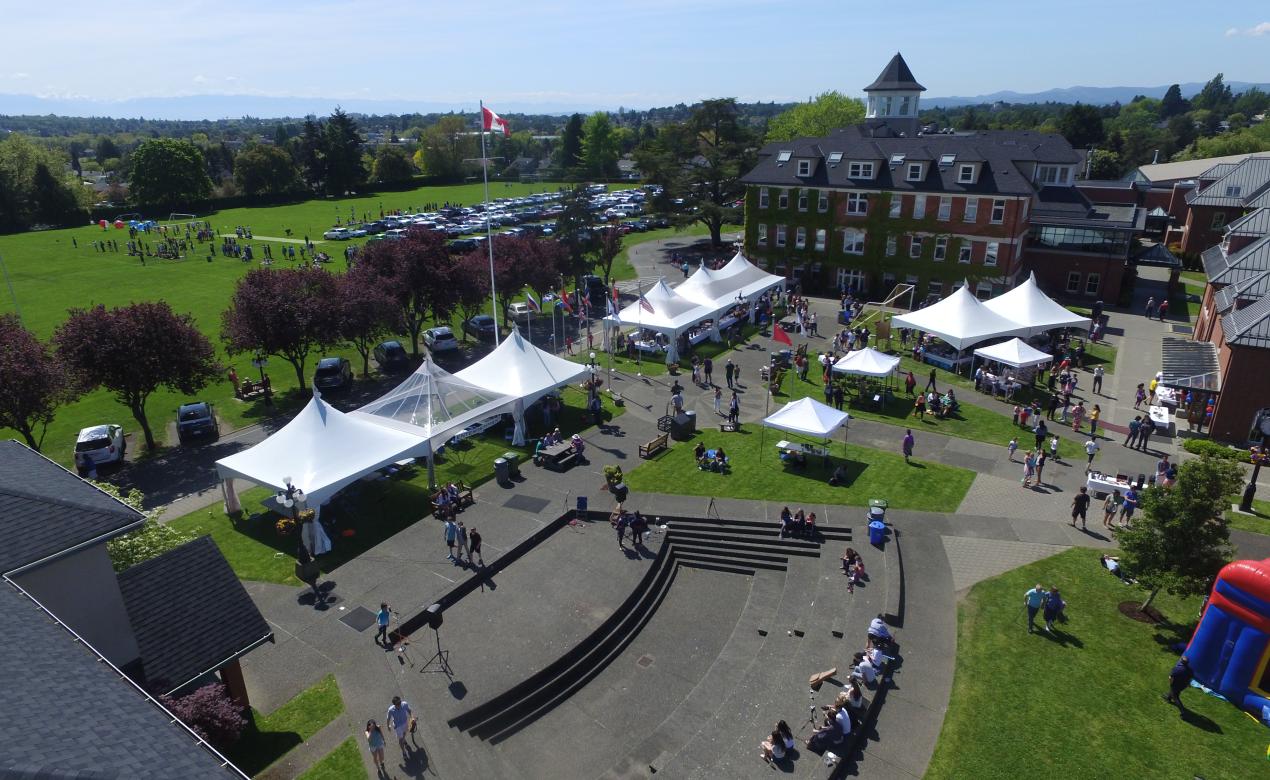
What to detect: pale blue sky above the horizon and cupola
<box><xmin>0</xmin><ymin>0</ymin><xmax>1270</xmax><ymax>108</ymax></box>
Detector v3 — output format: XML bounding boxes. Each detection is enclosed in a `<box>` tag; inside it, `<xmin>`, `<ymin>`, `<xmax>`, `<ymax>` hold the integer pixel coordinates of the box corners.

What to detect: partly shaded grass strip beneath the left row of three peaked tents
<box><xmin>166</xmin><ymin>387</ymin><xmax>625</xmax><ymax>586</ymax></box>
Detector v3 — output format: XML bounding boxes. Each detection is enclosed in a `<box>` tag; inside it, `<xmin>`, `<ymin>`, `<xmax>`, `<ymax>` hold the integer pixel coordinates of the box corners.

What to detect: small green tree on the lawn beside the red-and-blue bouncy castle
<box><xmin>1113</xmin><ymin>456</ymin><xmax>1243</xmax><ymax>610</ymax></box>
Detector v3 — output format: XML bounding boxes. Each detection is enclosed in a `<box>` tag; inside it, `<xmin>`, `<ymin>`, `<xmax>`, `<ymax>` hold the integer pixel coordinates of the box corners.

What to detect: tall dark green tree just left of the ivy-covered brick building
<box><xmin>635</xmin><ymin>98</ymin><xmax>754</xmax><ymax>246</ymax></box>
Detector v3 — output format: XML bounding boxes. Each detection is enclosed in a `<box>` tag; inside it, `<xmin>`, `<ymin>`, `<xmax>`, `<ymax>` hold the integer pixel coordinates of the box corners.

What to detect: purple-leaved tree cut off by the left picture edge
<box><xmin>0</xmin><ymin>314</ymin><xmax>76</xmax><ymax>451</ymax></box>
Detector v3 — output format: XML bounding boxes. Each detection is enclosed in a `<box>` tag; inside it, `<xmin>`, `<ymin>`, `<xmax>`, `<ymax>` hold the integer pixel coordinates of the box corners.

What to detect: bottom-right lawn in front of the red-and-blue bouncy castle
<box><xmin>924</xmin><ymin>549</ymin><xmax>1266</xmax><ymax>780</ymax></box>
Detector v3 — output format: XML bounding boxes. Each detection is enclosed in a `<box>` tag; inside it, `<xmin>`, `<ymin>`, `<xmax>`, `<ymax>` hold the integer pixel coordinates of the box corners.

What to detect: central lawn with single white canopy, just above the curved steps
<box><xmin>626</xmin><ymin>424</ymin><xmax>974</xmax><ymax>512</ymax></box>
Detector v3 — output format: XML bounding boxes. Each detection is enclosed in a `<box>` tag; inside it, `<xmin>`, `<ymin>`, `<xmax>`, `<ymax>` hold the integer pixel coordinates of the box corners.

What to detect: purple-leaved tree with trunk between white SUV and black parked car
<box><xmin>53</xmin><ymin>301</ymin><xmax>221</xmax><ymax>450</ymax></box>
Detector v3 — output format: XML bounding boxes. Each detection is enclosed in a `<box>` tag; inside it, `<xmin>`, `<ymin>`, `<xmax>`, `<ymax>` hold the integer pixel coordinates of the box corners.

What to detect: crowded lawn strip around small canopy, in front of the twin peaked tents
<box><xmin>772</xmin><ymin>365</ymin><xmax>1041</xmax><ymax>457</ymax></box>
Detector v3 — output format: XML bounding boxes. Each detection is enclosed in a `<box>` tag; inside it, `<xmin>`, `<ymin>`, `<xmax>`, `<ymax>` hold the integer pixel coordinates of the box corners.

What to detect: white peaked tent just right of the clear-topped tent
<box><xmin>455</xmin><ymin>328</ymin><xmax>587</xmax><ymax>446</ymax></box>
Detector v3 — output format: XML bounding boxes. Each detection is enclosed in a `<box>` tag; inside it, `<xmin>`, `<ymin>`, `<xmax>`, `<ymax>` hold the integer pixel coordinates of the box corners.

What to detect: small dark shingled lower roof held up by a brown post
<box><xmin>119</xmin><ymin>536</ymin><xmax>273</xmax><ymax>692</ymax></box>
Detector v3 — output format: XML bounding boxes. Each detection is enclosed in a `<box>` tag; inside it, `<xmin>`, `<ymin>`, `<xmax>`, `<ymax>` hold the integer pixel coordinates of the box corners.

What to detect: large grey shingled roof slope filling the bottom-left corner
<box><xmin>0</xmin><ymin>582</ymin><xmax>243</xmax><ymax>780</ymax></box>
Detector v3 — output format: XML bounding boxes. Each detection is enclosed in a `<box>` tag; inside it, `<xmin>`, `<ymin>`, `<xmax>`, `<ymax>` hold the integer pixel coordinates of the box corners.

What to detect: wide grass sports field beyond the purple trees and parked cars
<box><xmin>0</xmin><ymin>183</ymin><xmax>675</xmax><ymax>464</ymax></box>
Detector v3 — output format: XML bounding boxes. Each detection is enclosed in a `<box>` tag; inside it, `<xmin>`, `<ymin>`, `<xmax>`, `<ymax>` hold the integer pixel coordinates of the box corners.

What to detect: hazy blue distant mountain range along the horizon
<box><xmin>0</xmin><ymin>81</ymin><xmax>1270</xmax><ymax>119</ymax></box>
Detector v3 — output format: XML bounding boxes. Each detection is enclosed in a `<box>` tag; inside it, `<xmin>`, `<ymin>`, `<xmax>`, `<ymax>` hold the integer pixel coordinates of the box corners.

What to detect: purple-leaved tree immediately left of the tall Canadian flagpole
<box><xmin>357</xmin><ymin>227</ymin><xmax>460</xmax><ymax>357</ymax></box>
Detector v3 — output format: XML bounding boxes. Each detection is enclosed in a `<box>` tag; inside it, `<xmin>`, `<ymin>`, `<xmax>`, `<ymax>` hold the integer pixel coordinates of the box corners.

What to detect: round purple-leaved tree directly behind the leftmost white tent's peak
<box><xmin>221</xmin><ymin>268</ymin><xmax>339</xmax><ymax>387</ymax></box>
